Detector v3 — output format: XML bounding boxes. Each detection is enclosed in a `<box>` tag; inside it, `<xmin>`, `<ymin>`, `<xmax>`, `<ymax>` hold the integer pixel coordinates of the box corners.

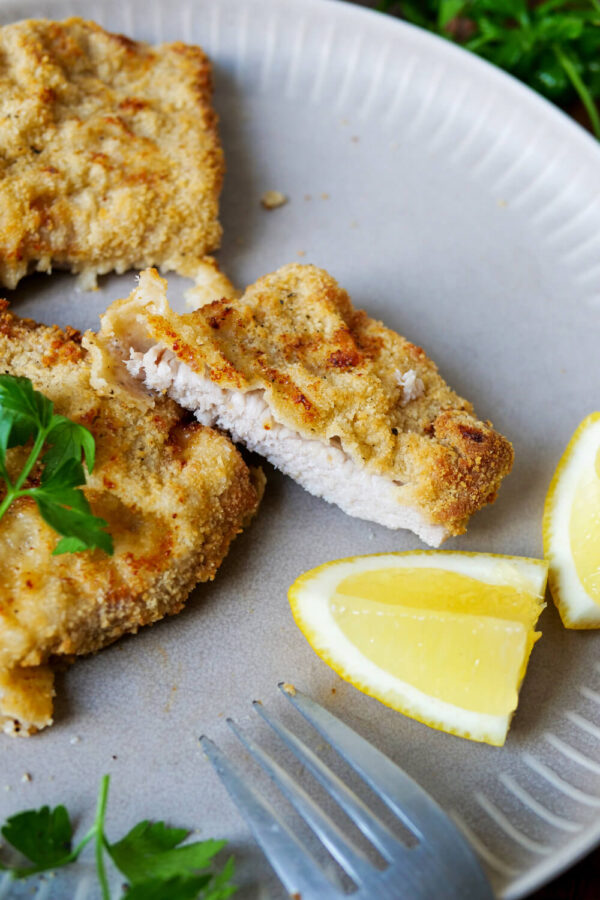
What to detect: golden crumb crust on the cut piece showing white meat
<box><xmin>108</xmin><ymin>264</ymin><xmax>513</xmax><ymax>534</ymax></box>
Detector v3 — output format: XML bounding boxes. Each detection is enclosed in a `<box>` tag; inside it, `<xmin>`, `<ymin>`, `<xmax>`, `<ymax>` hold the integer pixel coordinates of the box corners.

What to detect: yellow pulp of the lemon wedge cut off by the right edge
<box><xmin>569</xmin><ymin>451</ymin><xmax>600</xmax><ymax>604</ymax></box>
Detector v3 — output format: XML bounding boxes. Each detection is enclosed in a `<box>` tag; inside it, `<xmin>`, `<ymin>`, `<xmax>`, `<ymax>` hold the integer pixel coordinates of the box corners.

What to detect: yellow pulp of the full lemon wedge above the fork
<box><xmin>330</xmin><ymin>568</ymin><xmax>539</xmax><ymax>715</ymax></box>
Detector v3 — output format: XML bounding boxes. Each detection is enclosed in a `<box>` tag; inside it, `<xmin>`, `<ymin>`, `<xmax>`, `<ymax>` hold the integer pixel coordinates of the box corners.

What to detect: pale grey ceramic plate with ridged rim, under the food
<box><xmin>0</xmin><ymin>0</ymin><xmax>600</xmax><ymax>900</ymax></box>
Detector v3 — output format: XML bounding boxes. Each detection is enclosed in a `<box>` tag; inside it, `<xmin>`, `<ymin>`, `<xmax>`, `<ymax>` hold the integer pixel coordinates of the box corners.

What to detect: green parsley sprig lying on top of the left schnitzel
<box><xmin>0</xmin><ymin>375</ymin><xmax>113</xmax><ymax>555</ymax></box>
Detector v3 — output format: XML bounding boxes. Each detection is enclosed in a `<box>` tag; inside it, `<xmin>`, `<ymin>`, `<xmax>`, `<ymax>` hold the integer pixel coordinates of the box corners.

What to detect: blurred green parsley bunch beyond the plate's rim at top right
<box><xmin>379</xmin><ymin>0</ymin><xmax>600</xmax><ymax>139</ymax></box>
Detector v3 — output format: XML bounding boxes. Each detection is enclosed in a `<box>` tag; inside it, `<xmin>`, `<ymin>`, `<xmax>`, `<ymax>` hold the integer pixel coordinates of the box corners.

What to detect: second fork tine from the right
<box><xmin>253</xmin><ymin>700</ymin><xmax>403</xmax><ymax>862</ymax></box>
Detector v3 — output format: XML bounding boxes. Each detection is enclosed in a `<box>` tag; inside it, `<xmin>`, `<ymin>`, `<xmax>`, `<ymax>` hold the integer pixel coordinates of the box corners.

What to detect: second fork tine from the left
<box><xmin>227</xmin><ymin>719</ymin><xmax>373</xmax><ymax>887</ymax></box>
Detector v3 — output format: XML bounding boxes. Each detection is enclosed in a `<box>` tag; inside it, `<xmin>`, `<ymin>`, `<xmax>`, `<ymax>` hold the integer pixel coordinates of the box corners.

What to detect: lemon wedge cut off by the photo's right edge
<box><xmin>544</xmin><ymin>412</ymin><xmax>600</xmax><ymax>628</ymax></box>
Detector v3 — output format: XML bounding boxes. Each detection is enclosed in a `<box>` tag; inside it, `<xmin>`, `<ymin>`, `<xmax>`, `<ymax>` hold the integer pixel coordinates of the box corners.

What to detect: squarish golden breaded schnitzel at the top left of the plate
<box><xmin>0</xmin><ymin>18</ymin><xmax>224</xmax><ymax>288</ymax></box>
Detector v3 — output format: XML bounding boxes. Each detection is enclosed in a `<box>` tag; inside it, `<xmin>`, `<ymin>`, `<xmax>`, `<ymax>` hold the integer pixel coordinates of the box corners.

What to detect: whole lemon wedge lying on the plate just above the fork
<box><xmin>289</xmin><ymin>551</ymin><xmax>548</xmax><ymax>746</ymax></box>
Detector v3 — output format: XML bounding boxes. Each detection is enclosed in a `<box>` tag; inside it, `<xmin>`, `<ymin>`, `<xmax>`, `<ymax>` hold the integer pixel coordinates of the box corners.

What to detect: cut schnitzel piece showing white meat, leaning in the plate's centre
<box><xmin>96</xmin><ymin>265</ymin><xmax>513</xmax><ymax>546</ymax></box>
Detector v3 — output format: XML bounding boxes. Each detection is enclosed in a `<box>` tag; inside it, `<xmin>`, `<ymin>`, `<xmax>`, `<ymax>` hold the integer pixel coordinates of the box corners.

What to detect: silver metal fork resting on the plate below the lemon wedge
<box><xmin>200</xmin><ymin>684</ymin><xmax>494</xmax><ymax>900</ymax></box>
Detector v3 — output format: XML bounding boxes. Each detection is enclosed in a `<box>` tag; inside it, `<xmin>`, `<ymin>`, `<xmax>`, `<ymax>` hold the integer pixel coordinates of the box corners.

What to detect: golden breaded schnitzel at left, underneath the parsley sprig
<box><xmin>0</xmin><ymin>304</ymin><xmax>262</xmax><ymax>734</ymax></box>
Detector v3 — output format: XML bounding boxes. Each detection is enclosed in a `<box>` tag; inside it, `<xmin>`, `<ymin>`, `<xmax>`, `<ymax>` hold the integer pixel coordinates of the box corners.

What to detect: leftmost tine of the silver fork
<box><xmin>200</xmin><ymin>735</ymin><xmax>337</xmax><ymax>898</ymax></box>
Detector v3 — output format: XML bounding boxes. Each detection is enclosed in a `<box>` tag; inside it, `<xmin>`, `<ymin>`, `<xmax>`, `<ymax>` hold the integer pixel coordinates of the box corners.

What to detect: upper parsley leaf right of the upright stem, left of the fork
<box><xmin>108</xmin><ymin>821</ymin><xmax>225</xmax><ymax>885</ymax></box>
